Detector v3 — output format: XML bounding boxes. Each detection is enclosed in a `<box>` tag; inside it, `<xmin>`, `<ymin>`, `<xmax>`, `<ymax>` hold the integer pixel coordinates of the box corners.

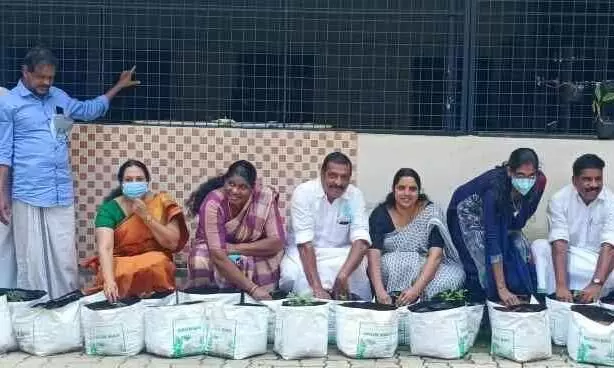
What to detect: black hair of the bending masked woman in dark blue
<box><xmin>491</xmin><ymin>148</ymin><xmax>539</xmax><ymax>211</ymax></box>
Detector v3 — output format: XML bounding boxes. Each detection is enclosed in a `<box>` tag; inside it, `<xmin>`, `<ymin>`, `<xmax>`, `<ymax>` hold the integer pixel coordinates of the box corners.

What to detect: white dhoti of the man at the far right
<box><xmin>531</xmin><ymin>239</ymin><xmax>614</xmax><ymax>296</ymax></box>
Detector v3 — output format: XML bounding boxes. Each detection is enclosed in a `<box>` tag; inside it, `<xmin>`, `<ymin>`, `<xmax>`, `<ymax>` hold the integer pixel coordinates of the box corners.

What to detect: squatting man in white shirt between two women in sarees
<box><xmin>279</xmin><ymin>152</ymin><xmax>371</xmax><ymax>300</ymax></box>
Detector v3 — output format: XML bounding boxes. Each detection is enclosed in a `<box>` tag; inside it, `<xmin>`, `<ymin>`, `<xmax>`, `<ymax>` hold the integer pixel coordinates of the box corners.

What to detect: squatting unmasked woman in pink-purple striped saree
<box><xmin>188</xmin><ymin>161</ymin><xmax>284</xmax><ymax>300</ymax></box>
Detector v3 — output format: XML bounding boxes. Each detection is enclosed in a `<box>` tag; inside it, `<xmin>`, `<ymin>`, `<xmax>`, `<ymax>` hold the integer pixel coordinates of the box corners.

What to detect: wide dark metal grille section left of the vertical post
<box><xmin>0</xmin><ymin>0</ymin><xmax>463</xmax><ymax>131</ymax></box>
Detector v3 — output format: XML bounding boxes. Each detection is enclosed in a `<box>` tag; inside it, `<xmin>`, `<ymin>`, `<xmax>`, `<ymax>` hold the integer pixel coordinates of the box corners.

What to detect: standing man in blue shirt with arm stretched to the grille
<box><xmin>0</xmin><ymin>47</ymin><xmax>139</xmax><ymax>298</ymax></box>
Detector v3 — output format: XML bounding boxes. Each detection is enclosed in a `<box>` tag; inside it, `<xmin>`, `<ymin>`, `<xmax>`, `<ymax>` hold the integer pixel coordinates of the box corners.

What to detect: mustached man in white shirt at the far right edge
<box><xmin>531</xmin><ymin>154</ymin><xmax>614</xmax><ymax>302</ymax></box>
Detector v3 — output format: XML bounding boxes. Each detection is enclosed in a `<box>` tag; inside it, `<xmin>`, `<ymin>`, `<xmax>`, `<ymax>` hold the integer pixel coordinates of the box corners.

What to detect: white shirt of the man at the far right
<box><xmin>548</xmin><ymin>184</ymin><xmax>614</xmax><ymax>252</ymax></box>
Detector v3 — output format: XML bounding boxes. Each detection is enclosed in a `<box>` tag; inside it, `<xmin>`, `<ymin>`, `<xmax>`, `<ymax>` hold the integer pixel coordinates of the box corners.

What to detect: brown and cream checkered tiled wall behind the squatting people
<box><xmin>71</xmin><ymin>124</ymin><xmax>357</xmax><ymax>263</ymax></box>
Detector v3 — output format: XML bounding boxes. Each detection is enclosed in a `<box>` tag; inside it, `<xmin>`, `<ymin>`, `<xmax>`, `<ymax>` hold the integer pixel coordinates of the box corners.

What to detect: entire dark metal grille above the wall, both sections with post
<box><xmin>0</xmin><ymin>0</ymin><xmax>614</xmax><ymax>134</ymax></box>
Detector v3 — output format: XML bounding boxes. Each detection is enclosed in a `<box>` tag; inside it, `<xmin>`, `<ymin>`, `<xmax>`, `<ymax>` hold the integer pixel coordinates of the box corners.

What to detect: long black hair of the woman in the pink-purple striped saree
<box><xmin>186</xmin><ymin>160</ymin><xmax>256</xmax><ymax>216</ymax></box>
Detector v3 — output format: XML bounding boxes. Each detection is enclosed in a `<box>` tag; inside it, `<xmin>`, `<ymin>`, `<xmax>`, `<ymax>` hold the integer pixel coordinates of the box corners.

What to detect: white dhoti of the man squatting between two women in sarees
<box><xmin>279</xmin><ymin>247</ymin><xmax>372</xmax><ymax>301</ymax></box>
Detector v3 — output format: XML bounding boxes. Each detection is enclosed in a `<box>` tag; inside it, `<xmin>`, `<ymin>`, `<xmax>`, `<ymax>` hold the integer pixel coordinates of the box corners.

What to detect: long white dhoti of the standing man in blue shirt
<box><xmin>12</xmin><ymin>201</ymin><xmax>79</xmax><ymax>298</ymax></box>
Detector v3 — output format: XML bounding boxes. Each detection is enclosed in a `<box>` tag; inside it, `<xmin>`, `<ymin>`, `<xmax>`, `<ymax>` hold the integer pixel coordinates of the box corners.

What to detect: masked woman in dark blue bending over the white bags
<box><xmin>447</xmin><ymin>148</ymin><xmax>546</xmax><ymax>305</ymax></box>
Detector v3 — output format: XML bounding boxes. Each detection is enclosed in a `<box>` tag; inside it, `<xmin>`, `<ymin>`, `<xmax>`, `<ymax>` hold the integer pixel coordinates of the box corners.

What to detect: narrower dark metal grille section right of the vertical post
<box><xmin>473</xmin><ymin>0</ymin><xmax>614</xmax><ymax>134</ymax></box>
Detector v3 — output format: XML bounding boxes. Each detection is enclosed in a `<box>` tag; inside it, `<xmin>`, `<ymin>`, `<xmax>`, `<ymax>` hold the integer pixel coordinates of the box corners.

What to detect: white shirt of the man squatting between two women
<box><xmin>288</xmin><ymin>178</ymin><xmax>371</xmax><ymax>248</ymax></box>
